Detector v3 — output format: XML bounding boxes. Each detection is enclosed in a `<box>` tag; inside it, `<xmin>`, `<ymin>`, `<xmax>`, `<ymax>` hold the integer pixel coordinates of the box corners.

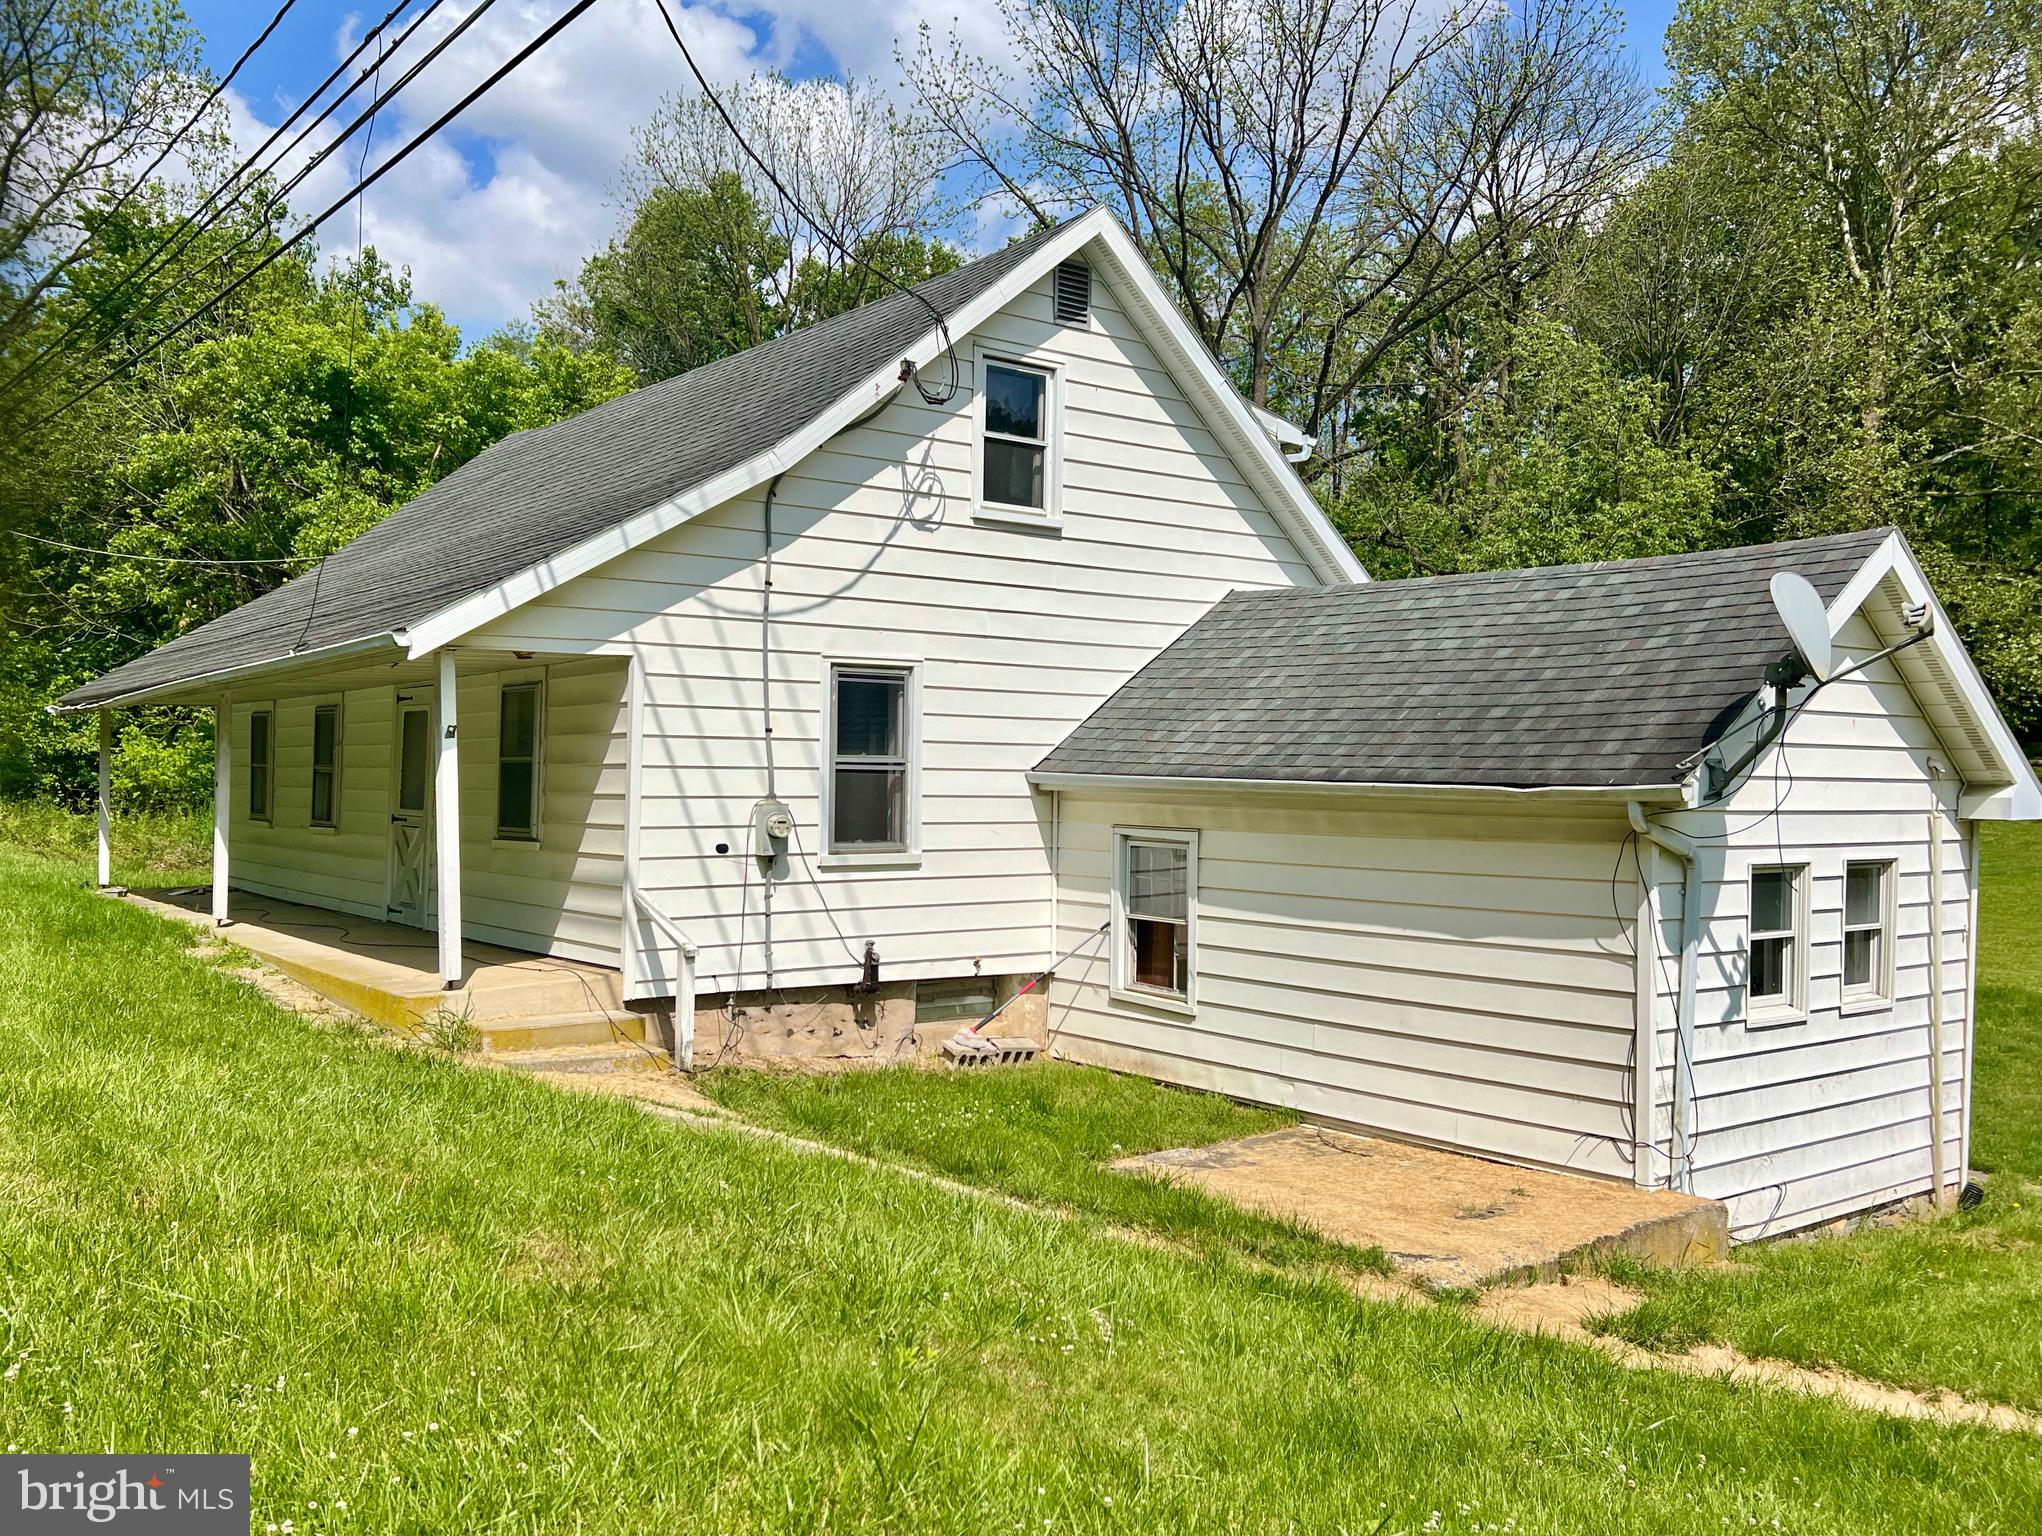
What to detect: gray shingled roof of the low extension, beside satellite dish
<box><xmin>1037</xmin><ymin>529</ymin><xmax>1889</xmax><ymax>788</ymax></box>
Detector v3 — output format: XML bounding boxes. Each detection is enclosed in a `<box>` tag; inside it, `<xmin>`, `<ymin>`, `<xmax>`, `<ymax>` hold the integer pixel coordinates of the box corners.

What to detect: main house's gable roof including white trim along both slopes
<box><xmin>57</xmin><ymin>208</ymin><xmax>1366</xmax><ymax>709</ymax></box>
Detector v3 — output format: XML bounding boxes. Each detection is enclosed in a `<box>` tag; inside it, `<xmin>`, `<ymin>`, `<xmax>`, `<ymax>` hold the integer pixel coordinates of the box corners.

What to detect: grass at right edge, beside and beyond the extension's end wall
<box><xmin>1601</xmin><ymin>823</ymin><xmax>2042</xmax><ymax>1407</ymax></box>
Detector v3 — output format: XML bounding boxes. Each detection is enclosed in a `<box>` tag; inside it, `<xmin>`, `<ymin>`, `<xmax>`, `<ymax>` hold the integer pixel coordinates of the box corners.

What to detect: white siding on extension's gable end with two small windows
<box><xmin>1654</xmin><ymin>617</ymin><xmax>1973</xmax><ymax>1238</ymax></box>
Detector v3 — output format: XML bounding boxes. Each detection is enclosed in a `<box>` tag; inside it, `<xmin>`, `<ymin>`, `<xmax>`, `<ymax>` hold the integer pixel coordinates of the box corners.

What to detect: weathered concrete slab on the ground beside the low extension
<box><xmin>1113</xmin><ymin>1125</ymin><xmax>1730</xmax><ymax>1287</ymax></box>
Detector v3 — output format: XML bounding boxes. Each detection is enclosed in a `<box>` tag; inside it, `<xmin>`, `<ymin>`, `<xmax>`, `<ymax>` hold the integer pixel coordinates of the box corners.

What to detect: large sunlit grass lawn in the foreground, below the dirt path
<box><xmin>0</xmin><ymin>854</ymin><xmax>2042</xmax><ymax>1536</ymax></box>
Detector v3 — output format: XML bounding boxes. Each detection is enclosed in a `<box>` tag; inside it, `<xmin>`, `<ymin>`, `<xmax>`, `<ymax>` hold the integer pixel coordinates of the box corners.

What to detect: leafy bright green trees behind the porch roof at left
<box><xmin>0</xmin><ymin>235</ymin><xmax>631</xmax><ymax>801</ymax></box>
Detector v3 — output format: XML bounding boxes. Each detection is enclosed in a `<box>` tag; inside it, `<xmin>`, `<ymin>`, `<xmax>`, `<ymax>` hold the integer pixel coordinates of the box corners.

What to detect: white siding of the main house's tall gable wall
<box><xmin>464</xmin><ymin>265</ymin><xmax>1315</xmax><ymax>991</ymax></box>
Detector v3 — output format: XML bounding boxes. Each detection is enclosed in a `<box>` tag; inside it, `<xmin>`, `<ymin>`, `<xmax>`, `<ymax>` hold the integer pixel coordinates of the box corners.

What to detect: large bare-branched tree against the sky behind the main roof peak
<box><xmin>903</xmin><ymin>0</ymin><xmax>1656</xmax><ymax>414</ymax></box>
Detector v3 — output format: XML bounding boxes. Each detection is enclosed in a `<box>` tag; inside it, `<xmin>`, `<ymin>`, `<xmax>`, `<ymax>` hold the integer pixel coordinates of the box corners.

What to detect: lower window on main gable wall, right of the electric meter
<box><xmin>829</xmin><ymin>664</ymin><xmax>915</xmax><ymax>854</ymax></box>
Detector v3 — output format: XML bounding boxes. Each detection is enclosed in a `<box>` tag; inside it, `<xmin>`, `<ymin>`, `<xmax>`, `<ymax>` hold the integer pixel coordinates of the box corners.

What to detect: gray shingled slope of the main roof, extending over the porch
<box><xmin>59</xmin><ymin>217</ymin><xmax>1078</xmax><ymax>707</ymax></box>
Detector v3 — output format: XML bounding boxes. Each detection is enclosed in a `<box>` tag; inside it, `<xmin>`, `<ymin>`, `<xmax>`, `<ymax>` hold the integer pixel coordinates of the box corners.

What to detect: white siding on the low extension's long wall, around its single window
<box><xmin>1050</xmin><ymin>790</ymin><xmax>1638</xmax><ymax>1177</ymax></box>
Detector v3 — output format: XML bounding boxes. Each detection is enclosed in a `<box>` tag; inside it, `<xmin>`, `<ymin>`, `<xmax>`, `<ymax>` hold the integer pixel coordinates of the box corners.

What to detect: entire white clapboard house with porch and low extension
<box><xmin>57</xmin><ymin>212</ymin><xmax>2042</xmax><ymax>1232</ymax></box>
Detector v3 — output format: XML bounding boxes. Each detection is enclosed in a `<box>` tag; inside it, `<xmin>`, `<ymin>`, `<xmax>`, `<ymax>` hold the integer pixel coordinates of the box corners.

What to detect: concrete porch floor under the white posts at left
<box><xmin>127</xmin><ymin>886</ymin><xmax>643</xmax><ymax>1044</ymax></box>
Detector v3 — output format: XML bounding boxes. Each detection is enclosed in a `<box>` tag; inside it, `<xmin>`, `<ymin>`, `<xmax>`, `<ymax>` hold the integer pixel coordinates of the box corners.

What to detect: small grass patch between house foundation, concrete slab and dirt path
<box><xmin>698</xmin><ymin>1062</ymin><xmax>1391</xmax><ymax>1275</ymax></box>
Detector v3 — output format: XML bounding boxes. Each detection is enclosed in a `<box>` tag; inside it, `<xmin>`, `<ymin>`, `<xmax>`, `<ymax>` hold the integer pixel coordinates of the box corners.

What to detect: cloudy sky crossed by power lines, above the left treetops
<box><xmin>231</xmin><ymin>0</ymin><xmax>984</xmax><ymax>337</ymax></box>
